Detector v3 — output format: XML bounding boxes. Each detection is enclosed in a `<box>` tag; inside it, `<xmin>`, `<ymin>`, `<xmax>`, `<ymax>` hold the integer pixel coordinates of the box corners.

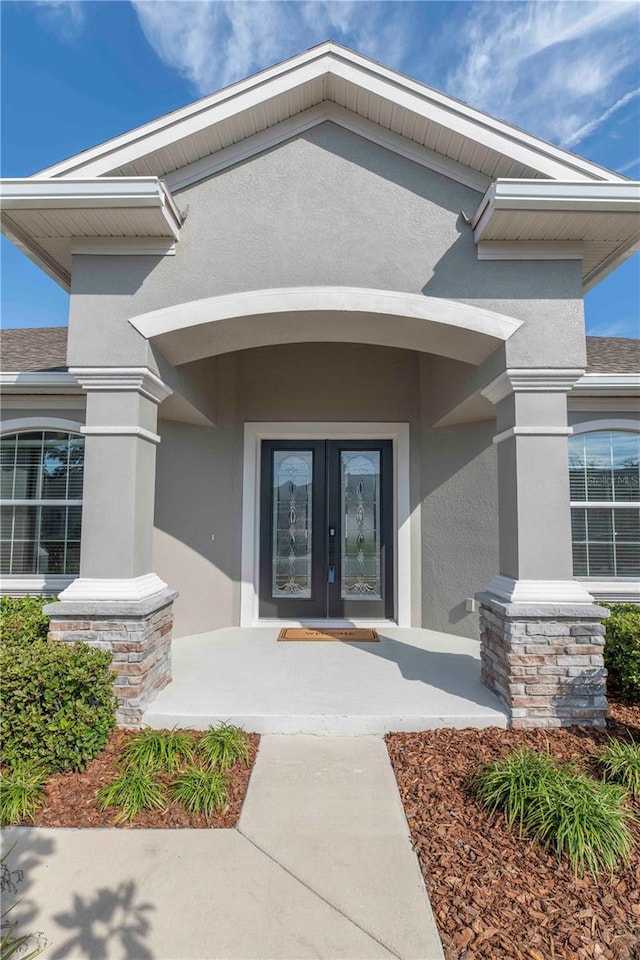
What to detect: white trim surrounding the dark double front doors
<box><xmin>240</xmin><ymin>421</ymin><xmax>411</xmax><ymax>627</ymax></box>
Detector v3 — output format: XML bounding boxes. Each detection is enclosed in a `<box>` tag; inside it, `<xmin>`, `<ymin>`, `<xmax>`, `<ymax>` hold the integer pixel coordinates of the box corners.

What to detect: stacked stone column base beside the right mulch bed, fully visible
<box><xmin>478</xmin><ymin>593</ymin><xmax>609</xmax><ymax>728</ymax></box>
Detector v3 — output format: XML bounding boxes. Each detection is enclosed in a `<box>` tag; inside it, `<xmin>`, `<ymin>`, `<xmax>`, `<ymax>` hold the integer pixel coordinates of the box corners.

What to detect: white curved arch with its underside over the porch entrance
<box><xmin>129</xmin><ymin>286</ymin><xmax>522</xmax><ymax>363</ymax></box>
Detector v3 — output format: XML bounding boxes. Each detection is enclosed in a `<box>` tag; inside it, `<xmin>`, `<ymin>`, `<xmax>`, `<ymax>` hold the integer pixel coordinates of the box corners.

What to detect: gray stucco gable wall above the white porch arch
<box><xmin>69</xmin><ymin>122</ymin><xmax>584</xmax><ymax>376</ymax></box>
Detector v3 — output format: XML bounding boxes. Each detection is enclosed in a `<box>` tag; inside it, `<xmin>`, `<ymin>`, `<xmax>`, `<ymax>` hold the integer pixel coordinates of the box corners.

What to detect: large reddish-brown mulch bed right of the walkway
<box><xmin>386</xmin><ymin>703</ymin><xmax>640</xmax><ymax>960</ymax></box>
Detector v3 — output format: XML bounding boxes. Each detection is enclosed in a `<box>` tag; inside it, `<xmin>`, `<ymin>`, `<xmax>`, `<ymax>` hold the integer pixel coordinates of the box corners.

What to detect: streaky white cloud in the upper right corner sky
<box><xmin>445</xmin><ymin>0</ymin><xmax>640</xmax><ymax>146</ymax></box>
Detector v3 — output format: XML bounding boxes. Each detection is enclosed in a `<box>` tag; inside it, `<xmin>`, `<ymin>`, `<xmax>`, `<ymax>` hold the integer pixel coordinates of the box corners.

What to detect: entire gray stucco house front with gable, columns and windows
<box><xmin>2</xmin><ymin>43</ymin><xmax>640</xmax><ymax>726</ymax></box>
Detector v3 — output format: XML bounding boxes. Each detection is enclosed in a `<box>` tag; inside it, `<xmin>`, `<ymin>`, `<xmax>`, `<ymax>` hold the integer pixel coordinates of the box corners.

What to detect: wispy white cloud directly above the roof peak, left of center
<box><xmin>132</xmin><ymin>0</ymin><xmax>405</xmax><ymax>95</ymax></box>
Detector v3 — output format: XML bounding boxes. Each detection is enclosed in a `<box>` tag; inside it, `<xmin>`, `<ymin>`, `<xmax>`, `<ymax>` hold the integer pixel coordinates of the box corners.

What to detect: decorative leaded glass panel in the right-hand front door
<box><xmin>340</xmin><ymin>450</ymin><xmax>382</xmax><ymax>600</ymax></box>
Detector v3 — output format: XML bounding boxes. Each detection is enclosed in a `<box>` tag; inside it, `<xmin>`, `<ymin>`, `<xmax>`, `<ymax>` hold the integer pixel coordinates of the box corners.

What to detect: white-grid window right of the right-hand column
<box><xmin>569</xmin><ymin>430</ymin><xmax>640</xmax><ymax>577</ymax></box>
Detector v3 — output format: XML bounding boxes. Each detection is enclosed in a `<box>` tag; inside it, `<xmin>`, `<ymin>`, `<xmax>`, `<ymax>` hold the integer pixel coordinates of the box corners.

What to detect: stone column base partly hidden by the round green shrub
<box><xmin>44</xmin><ymin>590</ymin><xmax>178</xmax><ymax>727</ymax></box>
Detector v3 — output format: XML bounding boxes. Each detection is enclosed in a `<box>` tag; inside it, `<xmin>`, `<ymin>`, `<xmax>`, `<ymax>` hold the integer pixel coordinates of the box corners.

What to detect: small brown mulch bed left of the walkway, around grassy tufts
<box><xmin>21</xmin><ymin>730</ymin><xmax>260</xmax><ymax>830</ymax></box>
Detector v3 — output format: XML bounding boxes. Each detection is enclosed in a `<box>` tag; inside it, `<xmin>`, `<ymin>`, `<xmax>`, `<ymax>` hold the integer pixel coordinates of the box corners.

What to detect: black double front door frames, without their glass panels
<box><xmin>258</xmin><ymin>437</ymin><xmax>396</xmax><ymax>621</ymax></box>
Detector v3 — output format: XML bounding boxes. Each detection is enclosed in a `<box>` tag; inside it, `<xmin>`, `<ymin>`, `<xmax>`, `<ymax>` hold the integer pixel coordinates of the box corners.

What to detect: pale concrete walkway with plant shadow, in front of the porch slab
<box><xmin>3</xmin><ymin>736</ymin><xmax>443</xmax><ymax>960</ymax></box>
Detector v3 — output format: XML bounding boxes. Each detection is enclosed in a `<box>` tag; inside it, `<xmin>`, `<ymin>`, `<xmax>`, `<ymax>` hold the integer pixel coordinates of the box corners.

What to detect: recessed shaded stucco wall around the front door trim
<box><xmin>154</xmin><ymin>344</ymin><xmax>498</xmax><ymax>637</ymax></box>
